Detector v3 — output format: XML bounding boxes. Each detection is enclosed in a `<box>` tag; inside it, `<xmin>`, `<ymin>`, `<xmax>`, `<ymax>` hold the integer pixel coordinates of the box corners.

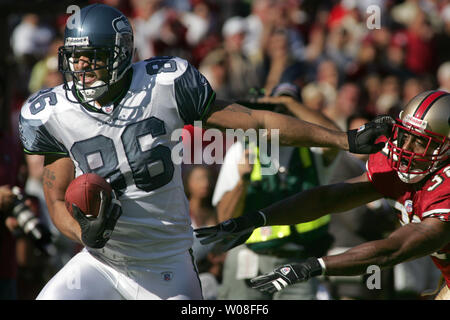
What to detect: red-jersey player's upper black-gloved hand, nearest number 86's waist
<box><xmin>194</xmin><ymin>211</ymin><xmax>266</xmax><ymax>252</ymax></box>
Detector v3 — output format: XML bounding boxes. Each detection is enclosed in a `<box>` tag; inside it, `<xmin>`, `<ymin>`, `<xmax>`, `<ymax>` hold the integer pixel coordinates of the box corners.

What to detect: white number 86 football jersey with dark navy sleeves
<box><xmin>20</xmin><ymin>57</ymin><xmax>215</xmax><ymax>261</ymax></box>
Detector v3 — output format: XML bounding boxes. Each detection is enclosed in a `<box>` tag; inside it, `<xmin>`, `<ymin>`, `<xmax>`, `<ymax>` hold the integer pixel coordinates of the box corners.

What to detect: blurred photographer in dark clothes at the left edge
<box><xmin>0</xmin><ymin>119</ymin><xmax>46</xmax><ymax>300</ymax></box>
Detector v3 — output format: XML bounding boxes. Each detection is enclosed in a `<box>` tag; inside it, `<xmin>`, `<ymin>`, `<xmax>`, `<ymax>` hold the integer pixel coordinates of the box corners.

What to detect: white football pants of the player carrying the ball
<box><xmin>36</xmin><ymin>249</ymin><xmax>202</xmax><ymax>300</ymax></box>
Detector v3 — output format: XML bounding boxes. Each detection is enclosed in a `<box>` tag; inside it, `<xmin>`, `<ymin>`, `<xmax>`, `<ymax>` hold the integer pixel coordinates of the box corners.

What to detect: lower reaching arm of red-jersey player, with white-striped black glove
<box><xmin>250</xmin><ymin>218</ymin><xmax>450</xmax><ymax>293</ymax></box>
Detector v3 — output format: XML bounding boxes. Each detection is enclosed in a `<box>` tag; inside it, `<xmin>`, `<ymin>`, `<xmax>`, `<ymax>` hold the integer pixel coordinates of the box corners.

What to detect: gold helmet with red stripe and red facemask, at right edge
<box><xmin>387</xmin><ymin>91</ymin><xmax>450</xmax><ymax>183</ymax></box>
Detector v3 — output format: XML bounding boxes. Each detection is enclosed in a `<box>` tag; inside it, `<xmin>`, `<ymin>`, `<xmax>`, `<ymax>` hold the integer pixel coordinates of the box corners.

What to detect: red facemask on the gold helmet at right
<box><xmin>387</xmin><ymin>117</ymin><xmax>450</xmax><ymax>183</ymax></box>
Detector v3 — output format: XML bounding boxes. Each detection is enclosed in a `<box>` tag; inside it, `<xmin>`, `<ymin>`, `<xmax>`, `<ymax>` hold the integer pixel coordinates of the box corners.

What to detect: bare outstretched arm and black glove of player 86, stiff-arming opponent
<box><xmin>204</xmin><ymin>100</ymin><xmax>392</xmax><ymax>153</ymax></box>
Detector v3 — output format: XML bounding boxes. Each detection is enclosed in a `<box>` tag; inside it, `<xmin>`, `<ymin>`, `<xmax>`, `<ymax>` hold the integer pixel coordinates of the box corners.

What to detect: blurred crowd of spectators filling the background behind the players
<box><xmin>0</xmin><ymin>0</ymin><xmax>450</xmax><ymax>299</ymax></box>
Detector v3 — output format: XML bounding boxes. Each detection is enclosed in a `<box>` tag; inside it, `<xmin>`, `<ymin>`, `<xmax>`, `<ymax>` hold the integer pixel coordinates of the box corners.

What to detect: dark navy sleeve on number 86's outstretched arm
<box><xmin>174</xmin><ymin>64</ymin><xmax>216</xmax><ymax>124</ymax></box>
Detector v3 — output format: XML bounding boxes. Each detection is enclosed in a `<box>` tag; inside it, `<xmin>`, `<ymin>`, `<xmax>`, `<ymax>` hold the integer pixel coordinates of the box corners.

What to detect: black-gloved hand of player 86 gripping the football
<box><xmin>72</xmin><ymin>191</ymin><xmax>122</xmax><ymax>249</ymax></box>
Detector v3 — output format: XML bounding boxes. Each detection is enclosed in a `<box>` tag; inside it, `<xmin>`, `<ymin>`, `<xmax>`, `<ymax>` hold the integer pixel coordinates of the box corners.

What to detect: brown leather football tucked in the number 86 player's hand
<box><xmin>64</xmin><ymin>173</ymin><xmax>112</xmax><ymax>217</ymax></box>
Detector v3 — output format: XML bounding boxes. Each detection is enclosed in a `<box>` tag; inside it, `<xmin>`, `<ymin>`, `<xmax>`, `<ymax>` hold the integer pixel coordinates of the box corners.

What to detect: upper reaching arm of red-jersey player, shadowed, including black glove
<box><xmin>194</xmin><ymin>174</ymin><xmax>382</xmax><ymax>250</ymax></box>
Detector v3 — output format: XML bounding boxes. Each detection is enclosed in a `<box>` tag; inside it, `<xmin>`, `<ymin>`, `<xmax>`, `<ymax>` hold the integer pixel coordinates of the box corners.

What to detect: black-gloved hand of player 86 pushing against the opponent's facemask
<box><xmin>347</xmin><ymin>115</ymin><xmax>395</xmax><ymax>154</ymax></box>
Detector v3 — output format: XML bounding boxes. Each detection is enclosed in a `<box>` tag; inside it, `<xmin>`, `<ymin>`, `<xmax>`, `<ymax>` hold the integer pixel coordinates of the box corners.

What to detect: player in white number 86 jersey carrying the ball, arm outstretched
<box><xmin>20</xmin><ymin>4</ymin><xmax>390</xmax><ymax>299</ymax></box>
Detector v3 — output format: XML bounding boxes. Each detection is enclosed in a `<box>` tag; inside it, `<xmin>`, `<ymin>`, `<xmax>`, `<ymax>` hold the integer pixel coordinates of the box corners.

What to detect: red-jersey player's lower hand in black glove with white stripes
<box><xmin>250</xmin><ymin>258</ymin><xmax>322</xmax><ymax>294</ymax></box>
